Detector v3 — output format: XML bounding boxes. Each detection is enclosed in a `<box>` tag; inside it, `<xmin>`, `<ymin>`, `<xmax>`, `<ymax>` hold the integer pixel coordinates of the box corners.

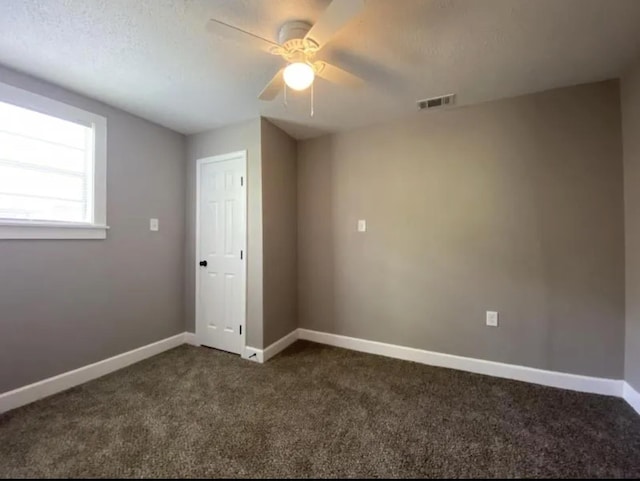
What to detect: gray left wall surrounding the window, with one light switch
<box><xmin>0</xmin><ymin>67</ymin><xmax>185</xmax><ymax>392</ymax></box>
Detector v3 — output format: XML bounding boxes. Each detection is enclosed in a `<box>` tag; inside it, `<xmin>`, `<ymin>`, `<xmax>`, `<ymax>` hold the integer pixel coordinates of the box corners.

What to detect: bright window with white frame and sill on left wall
<box><xmin>0</xmin><ymin>84</ymin><xmax>107</xmax><ymax>239</ymax></box>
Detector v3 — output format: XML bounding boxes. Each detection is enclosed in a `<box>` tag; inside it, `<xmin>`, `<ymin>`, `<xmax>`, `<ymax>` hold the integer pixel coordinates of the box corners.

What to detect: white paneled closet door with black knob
<box><xmin>196</xmin><ymin>152</ymin><xmax>247</xmax><ymax>354</ymax></box>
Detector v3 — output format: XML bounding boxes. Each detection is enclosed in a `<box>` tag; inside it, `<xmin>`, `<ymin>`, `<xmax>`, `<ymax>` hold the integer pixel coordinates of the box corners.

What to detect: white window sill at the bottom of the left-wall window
<box><xmin>0</xmin><ymin>220</ymin><xmax>109</xmax><ymax>239</ymax></box>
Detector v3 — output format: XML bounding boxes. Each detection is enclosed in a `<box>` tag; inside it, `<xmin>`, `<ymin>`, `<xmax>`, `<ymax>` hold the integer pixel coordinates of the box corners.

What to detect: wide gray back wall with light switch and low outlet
<box><xmin>298</xmin><ymin>81</ymin><xmax>624</xmax><ymax>379</ymax></box>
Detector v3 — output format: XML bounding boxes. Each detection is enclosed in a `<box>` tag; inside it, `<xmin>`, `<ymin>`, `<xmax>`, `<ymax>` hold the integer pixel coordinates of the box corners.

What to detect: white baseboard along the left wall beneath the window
<box><xmin>0</xmin><ymin>333</ymin><xmax>186</xmax><ymax>413</ymax></box>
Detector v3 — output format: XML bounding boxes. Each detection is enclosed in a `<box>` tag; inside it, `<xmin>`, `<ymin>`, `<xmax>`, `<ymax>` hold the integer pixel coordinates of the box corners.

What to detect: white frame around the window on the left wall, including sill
<box><xmin>0</xmin><ymin>83</ymin><xmax>109</xmax><ymax>239</ymax></box>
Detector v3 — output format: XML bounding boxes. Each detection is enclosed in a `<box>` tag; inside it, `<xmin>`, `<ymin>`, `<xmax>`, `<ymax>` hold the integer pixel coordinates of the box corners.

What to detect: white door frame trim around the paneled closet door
<box><xmin>193</xmin><ymin>150</ymin><xmax>249</xmax><ymax>357</ymax></box>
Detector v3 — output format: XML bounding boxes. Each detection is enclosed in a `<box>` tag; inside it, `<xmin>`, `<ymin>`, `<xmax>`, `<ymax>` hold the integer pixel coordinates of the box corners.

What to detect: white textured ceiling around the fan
<box><xmin>0</xmin><ymin>0</ymin><xmax>640</xmax><ymax>138</ymax></box>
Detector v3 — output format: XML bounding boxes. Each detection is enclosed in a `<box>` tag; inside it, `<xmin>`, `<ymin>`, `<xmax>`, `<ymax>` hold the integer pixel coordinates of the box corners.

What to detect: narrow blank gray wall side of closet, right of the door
<box><xmin>261</xmin><ymin>119</ymin><xmax>298</xmax><ymax>347</ymax></box>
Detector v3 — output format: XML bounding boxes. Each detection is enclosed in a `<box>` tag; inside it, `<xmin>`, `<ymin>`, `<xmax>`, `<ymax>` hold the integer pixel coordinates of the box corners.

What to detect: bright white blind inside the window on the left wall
<box><xmin>0</xmin><ymin>102</ymin><xmax>94</xmax><ymax>223</ymax></box>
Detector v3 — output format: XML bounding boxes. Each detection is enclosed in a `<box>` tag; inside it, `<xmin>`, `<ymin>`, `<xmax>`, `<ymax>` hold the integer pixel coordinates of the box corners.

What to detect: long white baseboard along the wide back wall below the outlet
<box><xmin>298</xmin><ymin>329</ymin><xmax>624</xmax><ymax>397</ymax></box>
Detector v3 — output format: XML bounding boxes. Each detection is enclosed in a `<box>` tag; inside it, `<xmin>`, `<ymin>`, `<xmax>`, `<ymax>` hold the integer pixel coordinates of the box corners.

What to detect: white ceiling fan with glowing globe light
<box><xmin>207</xmin><ymin>0</ymin><xmax>364</xmax><ymax>100</ymax></box>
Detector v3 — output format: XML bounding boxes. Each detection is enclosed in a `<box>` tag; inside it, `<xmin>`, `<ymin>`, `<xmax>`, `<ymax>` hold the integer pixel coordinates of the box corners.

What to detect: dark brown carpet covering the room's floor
<box><xmin>0</xmin><ymin>341</ymin><xmax>640</xmax><ymax>477</ymax></box>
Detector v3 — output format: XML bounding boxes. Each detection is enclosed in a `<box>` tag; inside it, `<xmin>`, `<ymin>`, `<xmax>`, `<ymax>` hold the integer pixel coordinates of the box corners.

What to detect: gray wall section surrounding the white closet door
<box><xmin>185</xmin><ymin>119</ymin><xmax>263</xmax><ymax>349</ymax></box>
